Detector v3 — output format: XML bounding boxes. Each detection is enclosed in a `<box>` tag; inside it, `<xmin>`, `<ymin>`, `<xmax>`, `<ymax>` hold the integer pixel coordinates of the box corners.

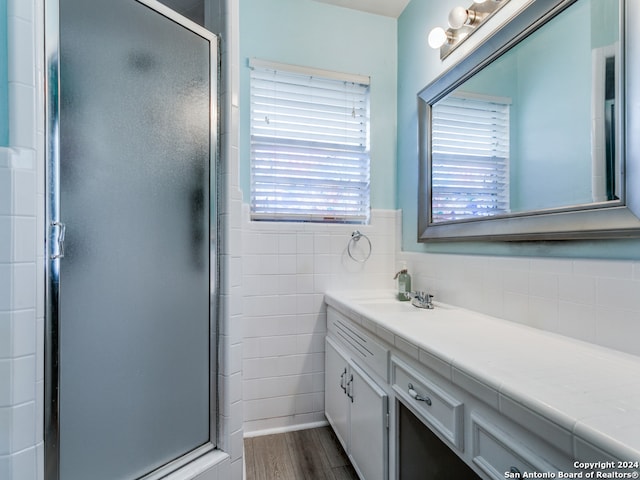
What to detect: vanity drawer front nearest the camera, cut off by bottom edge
<box><xmin>471</xmin><ymin>412</ymin><xmax>558</xmax><ymax>480</ymax></box>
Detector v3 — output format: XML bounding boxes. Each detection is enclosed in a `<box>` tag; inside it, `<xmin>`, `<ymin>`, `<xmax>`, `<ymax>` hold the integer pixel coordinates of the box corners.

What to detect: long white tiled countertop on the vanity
<box><xmin>325</xmin><ymin>290</ymin><xmax>640</xmax><ymax>461</ymax></box>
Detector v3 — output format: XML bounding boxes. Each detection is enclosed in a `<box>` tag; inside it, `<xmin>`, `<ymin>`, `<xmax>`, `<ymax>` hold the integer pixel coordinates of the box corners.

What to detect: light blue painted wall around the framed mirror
<box><xmin>397</xmin><ymin>0</ymin><xmax>640</xmax><ymax>259</ymax></box>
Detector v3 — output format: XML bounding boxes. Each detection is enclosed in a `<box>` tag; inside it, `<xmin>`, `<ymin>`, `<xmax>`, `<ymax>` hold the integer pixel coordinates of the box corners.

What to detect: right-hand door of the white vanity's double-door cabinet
<box><xmin>347</xmin><ymin>364</ymin><xmax>389</xmax><ymax>480</ymax></box>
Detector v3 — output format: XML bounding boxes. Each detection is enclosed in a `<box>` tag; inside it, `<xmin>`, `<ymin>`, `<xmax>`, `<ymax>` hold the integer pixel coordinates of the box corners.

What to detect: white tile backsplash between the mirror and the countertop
<box><xmin>399</xmin><ymin>252</ymin><xmax>640</xmax><ymax>355</ymax></box>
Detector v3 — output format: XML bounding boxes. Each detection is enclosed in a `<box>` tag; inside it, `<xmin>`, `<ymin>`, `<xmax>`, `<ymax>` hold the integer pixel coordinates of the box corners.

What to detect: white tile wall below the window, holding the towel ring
<box><xmin>242</xmin><ymin>205</ymin><xmax>397</xmax><ymax>435</ymax></box>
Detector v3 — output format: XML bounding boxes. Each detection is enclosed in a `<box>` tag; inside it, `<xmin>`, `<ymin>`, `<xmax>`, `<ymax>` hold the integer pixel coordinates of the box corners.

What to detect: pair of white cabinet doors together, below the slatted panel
<box><xmin>325</xmin><ymin>337</ymin><xmax>388</xmax><ymax>480</ymax></box>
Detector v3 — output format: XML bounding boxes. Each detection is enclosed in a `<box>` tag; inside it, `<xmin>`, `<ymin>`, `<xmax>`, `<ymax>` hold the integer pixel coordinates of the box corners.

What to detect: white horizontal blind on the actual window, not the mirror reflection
<box><xmin>251</xmin><ymin>60</ymin><xmax>370</xmax><ymax>223</ymax></box>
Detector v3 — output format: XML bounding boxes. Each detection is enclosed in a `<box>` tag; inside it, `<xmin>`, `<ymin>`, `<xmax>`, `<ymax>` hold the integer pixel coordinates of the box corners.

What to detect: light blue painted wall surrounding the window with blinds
<box><xmin>239</xmin><ymin>0</ymin><xmax>397</xmax><ymax>209</ymax></box>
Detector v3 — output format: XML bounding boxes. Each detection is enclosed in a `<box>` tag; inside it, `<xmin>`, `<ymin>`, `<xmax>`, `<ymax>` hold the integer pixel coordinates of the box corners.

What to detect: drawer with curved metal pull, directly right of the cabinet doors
<box><xmin>391</xmin><ymin>356</ymin><xmax>464</xmax><ymax>452</ymax></box>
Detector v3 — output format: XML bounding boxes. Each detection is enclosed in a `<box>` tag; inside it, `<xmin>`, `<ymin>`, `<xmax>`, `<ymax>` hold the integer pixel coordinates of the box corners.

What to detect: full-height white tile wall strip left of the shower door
<box><xmin>0</xmin><ymin>0</ymin><xmax>44</xmax><ymax>480</ymax></box>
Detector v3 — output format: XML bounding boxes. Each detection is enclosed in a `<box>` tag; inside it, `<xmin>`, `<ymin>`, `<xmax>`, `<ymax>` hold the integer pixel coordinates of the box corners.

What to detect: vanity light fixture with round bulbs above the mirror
<box><xmin>428</xmin><ymin>0</ymin><xmax>509</xmax><ymax>60</ymax></box>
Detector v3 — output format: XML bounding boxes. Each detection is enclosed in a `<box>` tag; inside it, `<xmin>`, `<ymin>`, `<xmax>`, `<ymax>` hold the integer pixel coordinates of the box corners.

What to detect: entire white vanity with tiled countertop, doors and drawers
<box><xmin>325</xmin><ymin>293</ymin><xmax>640</xmax><ymax>480</ymax></box>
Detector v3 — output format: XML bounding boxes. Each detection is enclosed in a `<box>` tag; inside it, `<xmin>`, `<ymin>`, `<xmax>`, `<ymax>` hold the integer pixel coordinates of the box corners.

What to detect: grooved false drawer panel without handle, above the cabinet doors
<box><xmin>327</xmin><ymin>307</ymin><xmax>389</xmax><ymax>382</ymax></box>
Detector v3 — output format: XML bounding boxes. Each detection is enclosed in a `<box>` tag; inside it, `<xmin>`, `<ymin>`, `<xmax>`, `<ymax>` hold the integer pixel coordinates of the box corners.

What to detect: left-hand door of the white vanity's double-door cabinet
<box><xmin>324</xmin><ymin>338</ymin><xmax>350</xmax><ymax>452</ymax></box>
